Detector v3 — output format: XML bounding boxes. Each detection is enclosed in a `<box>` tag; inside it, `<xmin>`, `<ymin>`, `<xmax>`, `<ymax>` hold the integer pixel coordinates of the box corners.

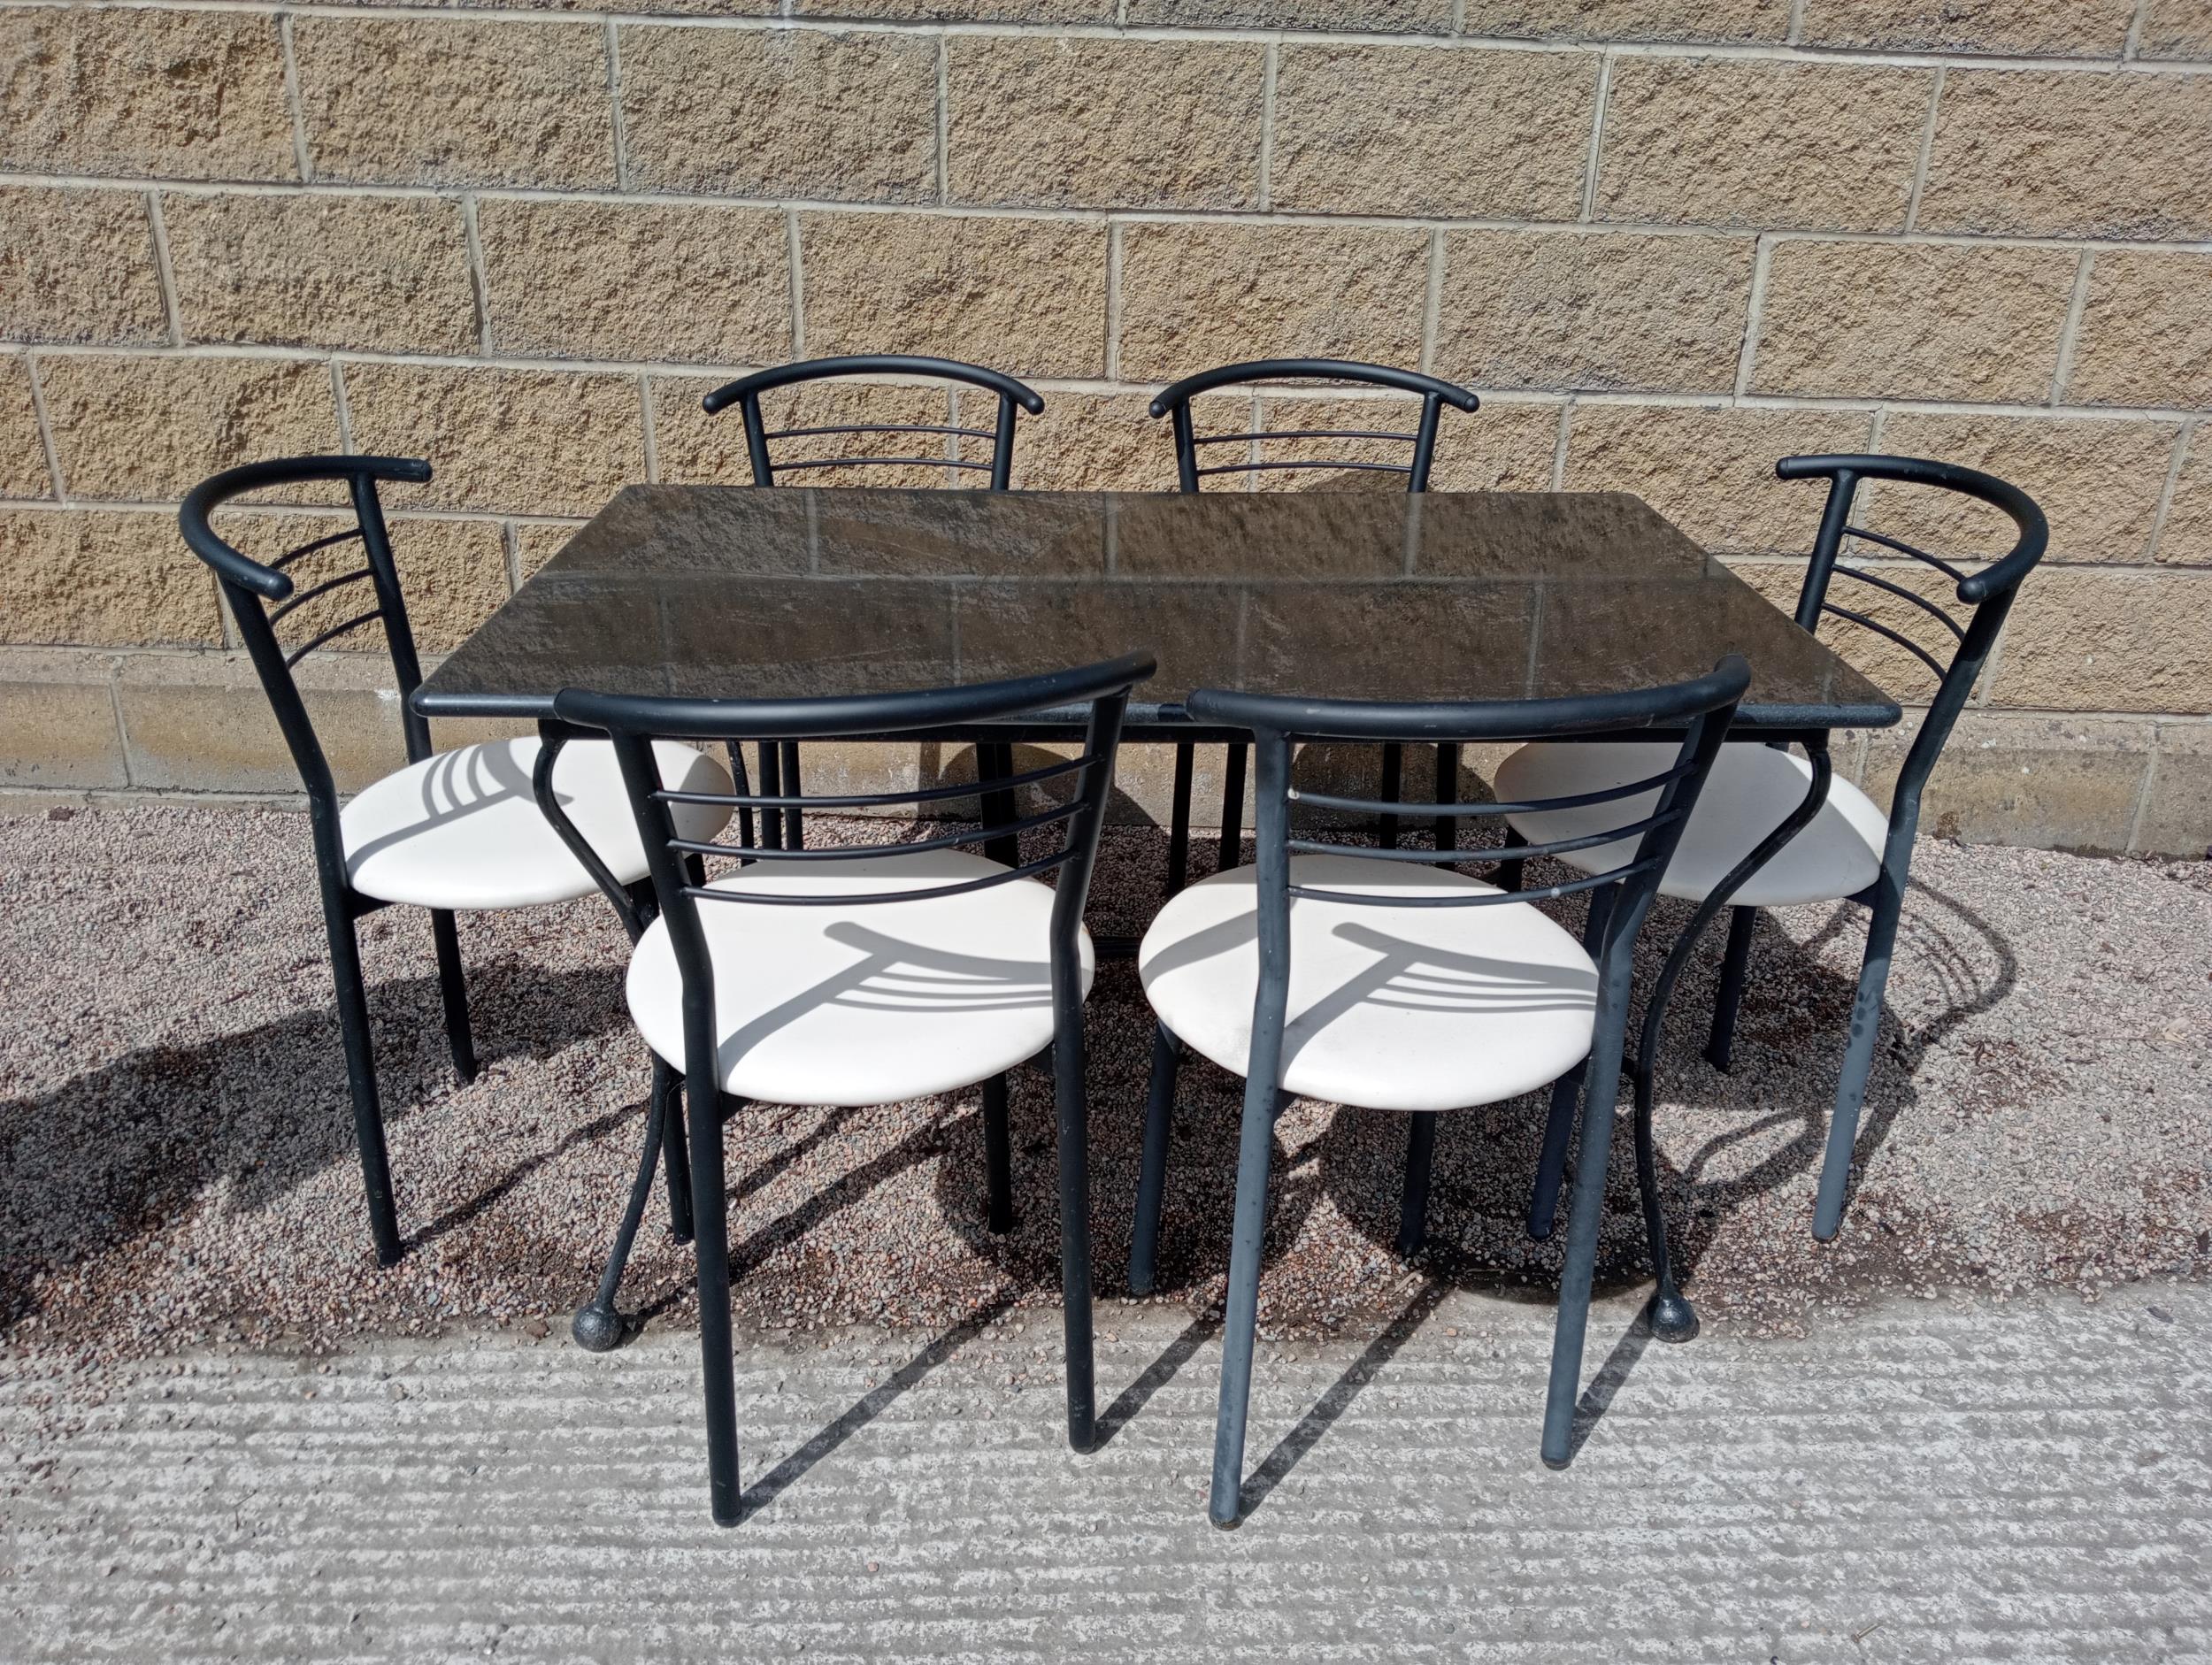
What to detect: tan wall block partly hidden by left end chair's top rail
<box><xmin>40</xmin><ymin>354</ymin><xmax>341</xmax><ymax>502</ymax></box>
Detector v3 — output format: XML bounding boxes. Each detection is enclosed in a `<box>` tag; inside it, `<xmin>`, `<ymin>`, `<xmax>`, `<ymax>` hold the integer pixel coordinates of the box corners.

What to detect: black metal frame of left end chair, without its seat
<box><xmin>177</xmin><ymin>456</ymin><xmax>453</xmax><ymax>1265</ymax></box>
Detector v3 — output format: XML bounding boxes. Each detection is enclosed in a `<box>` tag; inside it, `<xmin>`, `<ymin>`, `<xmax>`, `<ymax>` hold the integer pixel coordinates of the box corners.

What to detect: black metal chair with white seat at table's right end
<box><xmin>1495</xmin><ymin>456</ymin><xmax>2048</xmax><ymax>1247</ymax></box>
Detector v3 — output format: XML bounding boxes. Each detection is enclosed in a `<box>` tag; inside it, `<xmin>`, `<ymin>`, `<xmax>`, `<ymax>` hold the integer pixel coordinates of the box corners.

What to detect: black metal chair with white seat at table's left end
<box><xmin>177</xmin><ymin>457</ymin><xmax>730</xmax><ymax>1265</ymax></box>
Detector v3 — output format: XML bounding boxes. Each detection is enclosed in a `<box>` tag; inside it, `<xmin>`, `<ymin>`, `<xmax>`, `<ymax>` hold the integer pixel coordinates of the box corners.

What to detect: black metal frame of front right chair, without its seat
<box><xmin>1133</xmin><ymin>656</ymin><xmax>1750</xmax><ymax>1526</ymax></box>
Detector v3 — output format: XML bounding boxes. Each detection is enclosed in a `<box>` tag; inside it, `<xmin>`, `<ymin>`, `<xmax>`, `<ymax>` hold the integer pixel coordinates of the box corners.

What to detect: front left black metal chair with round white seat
<box><xmin>556</xmin><ymin>655</ymin><xmax>1153</xmax><ymax>1526</ymax></box>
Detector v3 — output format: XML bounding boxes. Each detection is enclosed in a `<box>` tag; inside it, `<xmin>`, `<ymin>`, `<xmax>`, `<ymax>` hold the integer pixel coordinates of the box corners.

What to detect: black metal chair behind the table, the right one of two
<box><xmin>1150</xmin><ymin>358</ymin><xmax>1482</xmax><ymax>895</ymax></box>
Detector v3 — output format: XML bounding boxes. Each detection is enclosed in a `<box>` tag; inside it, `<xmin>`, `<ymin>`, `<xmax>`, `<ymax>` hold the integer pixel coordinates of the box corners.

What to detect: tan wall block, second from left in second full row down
<box><xmin>162</xmin><ymin>195</ymin><xmax>478</xmax><ymax>351</ymax></box>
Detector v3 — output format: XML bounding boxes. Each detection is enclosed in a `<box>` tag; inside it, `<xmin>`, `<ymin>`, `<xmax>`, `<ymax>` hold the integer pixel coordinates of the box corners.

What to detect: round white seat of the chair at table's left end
<box><xmin>339</xmin><ymin>739</ymin><xmax>733</xmax><ymax>911</ymax></box>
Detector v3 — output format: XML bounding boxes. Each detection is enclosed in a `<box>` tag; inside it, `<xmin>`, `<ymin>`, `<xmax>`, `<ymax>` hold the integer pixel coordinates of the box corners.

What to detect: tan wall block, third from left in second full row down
<box><xmin>476</xmin><ymin>201</ymin><xmax>792</xmax><ymax>364</ymax></box>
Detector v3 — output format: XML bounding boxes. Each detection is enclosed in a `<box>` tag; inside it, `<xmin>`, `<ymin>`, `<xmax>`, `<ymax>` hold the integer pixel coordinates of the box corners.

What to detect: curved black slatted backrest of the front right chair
<box><xmin>1186</xmin><ymin>655</ymin><xmax>1750</xmax><ymax>988</ymax></box>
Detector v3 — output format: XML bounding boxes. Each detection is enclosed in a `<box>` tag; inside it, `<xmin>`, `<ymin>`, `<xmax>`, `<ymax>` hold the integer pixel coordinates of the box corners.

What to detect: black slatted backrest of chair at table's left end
<box><xmin>177</xmin><ymin>457</ymin><xmax>442</xmax><ymax>814</ymax></box>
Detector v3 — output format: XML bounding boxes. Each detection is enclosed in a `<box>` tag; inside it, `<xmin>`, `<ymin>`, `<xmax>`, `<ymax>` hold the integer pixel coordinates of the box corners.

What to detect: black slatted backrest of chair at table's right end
<box><xmin>1774</xmin><ymin>456</ymin><xmax>2051</xmax><ymax>845</ymax></box>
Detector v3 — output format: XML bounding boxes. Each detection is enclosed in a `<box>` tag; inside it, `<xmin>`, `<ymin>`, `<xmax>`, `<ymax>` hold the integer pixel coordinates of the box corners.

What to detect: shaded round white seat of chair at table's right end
<box><xmin>1491</xmin><ymin>740</ymin><xmax>1889</xmax><ymax>907</ymax></box>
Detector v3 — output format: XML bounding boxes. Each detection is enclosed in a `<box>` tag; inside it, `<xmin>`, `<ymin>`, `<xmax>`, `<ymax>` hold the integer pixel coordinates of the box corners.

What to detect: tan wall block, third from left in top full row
<box><xmin>619</xmin><ymin>27</ymin><xmax>938</xmax><ymax>201</ymax></box>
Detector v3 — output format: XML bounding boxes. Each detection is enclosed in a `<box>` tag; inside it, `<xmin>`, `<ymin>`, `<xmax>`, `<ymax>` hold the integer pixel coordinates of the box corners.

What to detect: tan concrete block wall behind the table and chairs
<box><xmin>0</xmin><ymin>0</ymin><xmax>2212</xmax><ymax>854</ymax></box>
